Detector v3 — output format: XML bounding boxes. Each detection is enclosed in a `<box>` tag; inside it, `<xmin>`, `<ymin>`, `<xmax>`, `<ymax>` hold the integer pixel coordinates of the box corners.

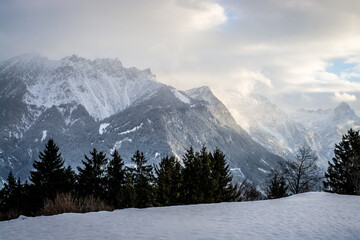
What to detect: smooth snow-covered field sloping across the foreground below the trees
<box><xmin>0</xmin><ymin>193</ymin><xmax>360</xmax><ymax>240</ymax></box>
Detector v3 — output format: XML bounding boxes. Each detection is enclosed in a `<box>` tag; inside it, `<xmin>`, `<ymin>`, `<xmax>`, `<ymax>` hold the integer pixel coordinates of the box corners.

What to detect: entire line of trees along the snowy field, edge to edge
<box><xmin>0</xmin><ymin>129</ymin><xmax>360</xmax><ymax>220</ymax></box>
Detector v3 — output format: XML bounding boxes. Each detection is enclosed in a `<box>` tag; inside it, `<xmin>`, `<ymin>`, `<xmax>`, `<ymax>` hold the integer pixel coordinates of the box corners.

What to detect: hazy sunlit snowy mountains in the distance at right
<box><xmin>227</xmin><ymin>92</ymin><xmax>360</xmax><ymax>169</ymax></box>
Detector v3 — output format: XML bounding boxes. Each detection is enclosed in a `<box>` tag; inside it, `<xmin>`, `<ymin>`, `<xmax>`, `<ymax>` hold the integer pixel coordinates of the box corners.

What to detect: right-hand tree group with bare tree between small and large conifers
<box><xmin>265</xmin><ymin>129</ymin><xmax>360</xmax><ymax>199</ymax></box>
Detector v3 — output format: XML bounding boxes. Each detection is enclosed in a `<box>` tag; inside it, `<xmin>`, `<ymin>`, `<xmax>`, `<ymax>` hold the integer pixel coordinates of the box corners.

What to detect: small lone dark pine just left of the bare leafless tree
<box><xmin>266</xmin><ymin>171</ymin><xmax>288</xmax><ymax>199</ymax></box>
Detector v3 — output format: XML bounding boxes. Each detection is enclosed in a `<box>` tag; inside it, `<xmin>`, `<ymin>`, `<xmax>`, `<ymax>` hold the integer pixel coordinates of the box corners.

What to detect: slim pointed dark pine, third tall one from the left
<box><xmin>107</xmin><ymin>150</ymin><xmax>126</xmax><ymax>209</ymax></box>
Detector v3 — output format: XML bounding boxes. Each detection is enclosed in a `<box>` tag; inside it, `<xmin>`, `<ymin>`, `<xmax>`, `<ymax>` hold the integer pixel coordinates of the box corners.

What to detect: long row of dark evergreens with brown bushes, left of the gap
<box><xmin>0</xmin><ymin>142</ymin><xmax>241</xmax><ymax>219</ymax></box>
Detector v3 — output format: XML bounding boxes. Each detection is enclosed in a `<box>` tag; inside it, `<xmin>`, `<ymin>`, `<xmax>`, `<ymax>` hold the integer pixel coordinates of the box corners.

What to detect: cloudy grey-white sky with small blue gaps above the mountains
<box><xmin>0</xmin><ymin>0</ymin><xmax>360</xmax><ymax>114</ymax></box>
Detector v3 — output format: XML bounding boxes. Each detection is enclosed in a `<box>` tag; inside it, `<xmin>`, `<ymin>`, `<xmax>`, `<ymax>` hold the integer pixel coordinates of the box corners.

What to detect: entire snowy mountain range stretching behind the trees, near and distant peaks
<box><xmin>0</xmin><ymin>54</ymin><xmax>360</xmax><ymax>184</ymax></box>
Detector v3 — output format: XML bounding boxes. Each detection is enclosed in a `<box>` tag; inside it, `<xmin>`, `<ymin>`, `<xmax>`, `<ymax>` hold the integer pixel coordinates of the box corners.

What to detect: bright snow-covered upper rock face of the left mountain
<box><xmin>9</xmin><ymin>55</ymin><xmax>162</xmax><ymax>120</ymax></box>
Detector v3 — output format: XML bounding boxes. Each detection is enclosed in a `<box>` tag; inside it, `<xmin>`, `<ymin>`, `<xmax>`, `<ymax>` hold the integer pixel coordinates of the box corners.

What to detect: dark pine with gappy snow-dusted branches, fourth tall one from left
<box><xmin>131</xmin><ymin>151</ymin><xmax>154</xmax><ymax>208</ymax></box>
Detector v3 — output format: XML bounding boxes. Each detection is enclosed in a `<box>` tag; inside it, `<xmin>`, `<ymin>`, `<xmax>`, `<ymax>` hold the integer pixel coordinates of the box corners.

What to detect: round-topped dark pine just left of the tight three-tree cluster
<box><xmin>155</xmin><ymin>156</ymin><xmax>182</xmax><ymax>206</ymax></box>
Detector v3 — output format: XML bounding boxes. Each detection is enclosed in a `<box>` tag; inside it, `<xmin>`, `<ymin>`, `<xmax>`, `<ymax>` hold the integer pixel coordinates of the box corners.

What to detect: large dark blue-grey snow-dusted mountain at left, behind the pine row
<box><xmin>0</xmin><ymin>54</ymin><xmax>283</xmax><ymax>184</ymax></box>
